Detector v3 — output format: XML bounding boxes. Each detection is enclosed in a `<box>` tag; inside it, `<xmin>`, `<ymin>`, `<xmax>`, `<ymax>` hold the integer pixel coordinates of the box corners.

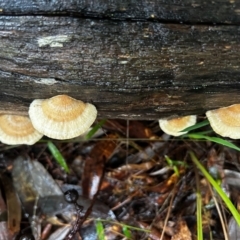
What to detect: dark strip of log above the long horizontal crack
<box><xmin>0</xmin><ymin>0</ymin><xmax>240</xmax><ymax>24</ymax></box>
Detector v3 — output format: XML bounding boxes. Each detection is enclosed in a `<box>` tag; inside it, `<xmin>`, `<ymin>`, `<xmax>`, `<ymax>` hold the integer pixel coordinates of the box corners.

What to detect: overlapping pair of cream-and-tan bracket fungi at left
<box><xmin>0</xmin><ymin>95</ymin><xmax>97</xmax><ymax>145</ymax></box>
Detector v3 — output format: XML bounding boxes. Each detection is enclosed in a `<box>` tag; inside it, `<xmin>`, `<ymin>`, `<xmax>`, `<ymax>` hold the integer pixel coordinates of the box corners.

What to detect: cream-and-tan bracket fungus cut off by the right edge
<box><xmin>206</xmin><ymin>104</ymin><xmax>240</xmax><ymax>139</ymax></box>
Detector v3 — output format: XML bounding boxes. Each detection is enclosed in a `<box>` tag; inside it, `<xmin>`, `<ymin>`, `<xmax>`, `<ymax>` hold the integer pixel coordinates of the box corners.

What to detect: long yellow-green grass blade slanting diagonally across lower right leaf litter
<box><xmin>189</xmin><ymin>152</ymin><xmax>240</xmax><ymax>226</ymax></box>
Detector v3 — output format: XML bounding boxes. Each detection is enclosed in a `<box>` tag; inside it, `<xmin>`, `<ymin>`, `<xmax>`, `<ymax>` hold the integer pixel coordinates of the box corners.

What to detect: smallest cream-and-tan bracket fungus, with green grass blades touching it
<box><xmin>159</xmin><ymin>115</ymin><xmax>197</xmax><ymax>136</ymax></box>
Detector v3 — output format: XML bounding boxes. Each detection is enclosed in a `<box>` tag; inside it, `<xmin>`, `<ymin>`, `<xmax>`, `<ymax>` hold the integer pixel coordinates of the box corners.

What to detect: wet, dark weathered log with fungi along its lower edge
<box><xmin>0</xmin><ymin>0</ymin><xmax>240</xmax><ymax>119</ymax></box>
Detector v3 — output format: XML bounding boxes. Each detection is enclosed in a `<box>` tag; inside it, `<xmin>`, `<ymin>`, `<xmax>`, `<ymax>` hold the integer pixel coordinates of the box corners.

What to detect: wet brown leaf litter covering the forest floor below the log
<box><xmin>0</xmin><ymin>119</ymin><xmax>240</xmax><ymax>240</ymax></box>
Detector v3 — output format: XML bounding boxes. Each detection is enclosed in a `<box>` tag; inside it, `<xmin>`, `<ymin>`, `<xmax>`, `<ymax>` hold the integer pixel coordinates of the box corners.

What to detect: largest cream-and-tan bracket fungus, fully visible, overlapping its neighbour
<box><xmin>29</xmin><ymin>95</ymin><xmax>97</xmax><ymax>139</ymax></box>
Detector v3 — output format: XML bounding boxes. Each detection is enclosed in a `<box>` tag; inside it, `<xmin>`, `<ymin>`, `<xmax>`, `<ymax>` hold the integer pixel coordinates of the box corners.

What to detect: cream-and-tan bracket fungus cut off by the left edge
<box><xmin>0</xmin><ymin>115</ymin><xmax>43</xmax><ymax>145</ymax></box>
